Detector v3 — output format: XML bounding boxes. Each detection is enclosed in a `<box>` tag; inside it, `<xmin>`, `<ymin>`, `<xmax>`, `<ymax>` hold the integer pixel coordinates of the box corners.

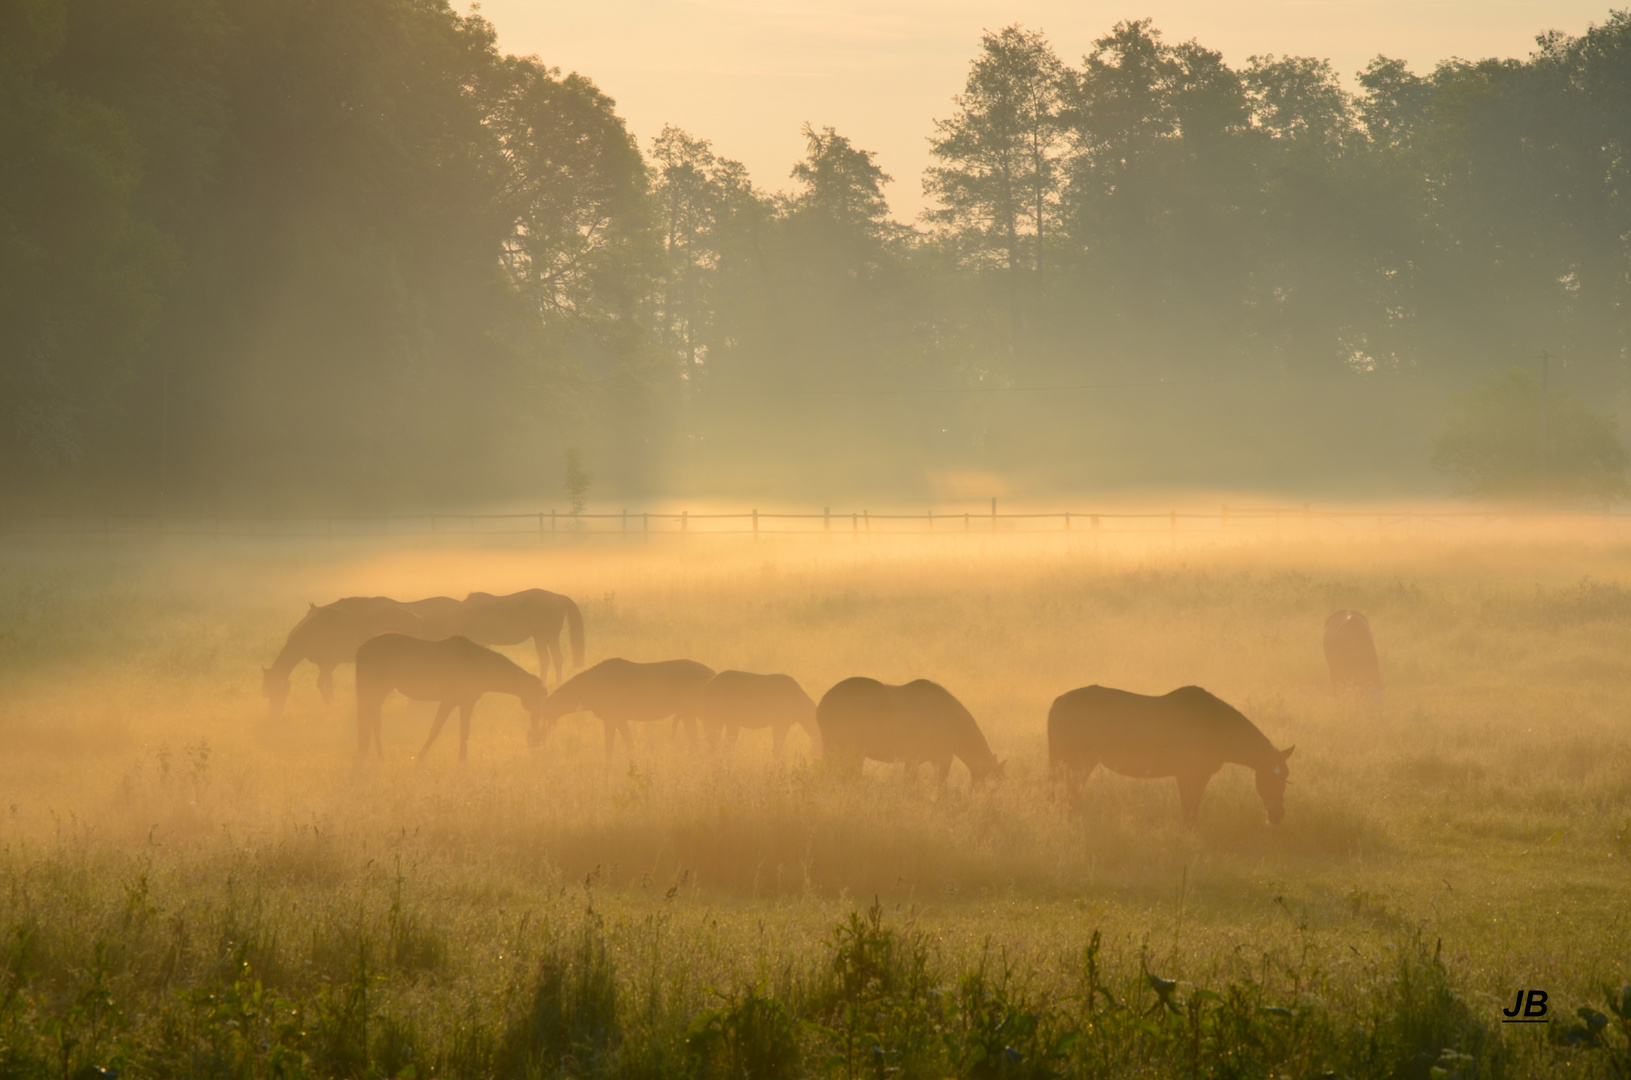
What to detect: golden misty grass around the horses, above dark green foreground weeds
<box><xmin>0</xmin><ymin>535</ymin><xmax>1631</xmax><ymax>1070</ymax></box>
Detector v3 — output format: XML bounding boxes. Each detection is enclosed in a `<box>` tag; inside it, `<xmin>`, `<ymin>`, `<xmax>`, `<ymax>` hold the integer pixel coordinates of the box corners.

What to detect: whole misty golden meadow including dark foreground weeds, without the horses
<box><xmin>0</xmin><ymin>527</ymin><xmax>1631</xmax><ymax>1080</ymax></box>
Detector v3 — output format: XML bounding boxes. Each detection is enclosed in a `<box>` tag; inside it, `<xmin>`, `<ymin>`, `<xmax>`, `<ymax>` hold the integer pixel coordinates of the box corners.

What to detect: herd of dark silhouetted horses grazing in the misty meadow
<box><xmin>263</xmin><ymin>589</ymin><xmax>1381</xmax><ymax>825</ymax></box>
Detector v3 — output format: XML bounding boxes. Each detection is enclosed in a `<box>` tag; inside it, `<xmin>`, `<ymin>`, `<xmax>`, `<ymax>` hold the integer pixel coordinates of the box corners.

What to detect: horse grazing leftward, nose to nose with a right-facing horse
<box><xmin>527</xmin><ymin>657</ymin><xmax>714</xmax><ymax>759</ymax></box>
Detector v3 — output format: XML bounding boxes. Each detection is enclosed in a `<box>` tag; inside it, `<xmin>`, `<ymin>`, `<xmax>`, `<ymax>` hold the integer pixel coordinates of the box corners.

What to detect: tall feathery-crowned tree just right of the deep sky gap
<box><xmin>923</xmin><ymin>24</ymin><xmax>1063</xmax><ymax>338</ymax></box>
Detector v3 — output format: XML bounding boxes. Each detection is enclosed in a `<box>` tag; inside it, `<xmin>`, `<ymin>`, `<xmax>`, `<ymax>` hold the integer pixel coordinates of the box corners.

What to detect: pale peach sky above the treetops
<box><xmin>481</xmin><ymin>0</ymin><xmax>1610</xmax><ymax>220</ymax></box>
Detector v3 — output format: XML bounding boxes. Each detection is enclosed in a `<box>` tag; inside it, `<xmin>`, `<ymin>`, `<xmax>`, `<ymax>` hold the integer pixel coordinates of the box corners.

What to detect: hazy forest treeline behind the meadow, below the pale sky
<box><xmin>0</xmin><ymin>0</ymin><xmax>1631</xmax><ymax>509</ymax></box>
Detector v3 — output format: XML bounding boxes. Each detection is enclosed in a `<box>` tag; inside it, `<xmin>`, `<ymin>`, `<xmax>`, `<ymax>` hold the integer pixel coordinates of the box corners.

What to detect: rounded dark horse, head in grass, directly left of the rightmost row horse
<box><xmin>816</xmin><ymin>677</ymin><xmax>1003</xmax><ymax>785</ymax></box>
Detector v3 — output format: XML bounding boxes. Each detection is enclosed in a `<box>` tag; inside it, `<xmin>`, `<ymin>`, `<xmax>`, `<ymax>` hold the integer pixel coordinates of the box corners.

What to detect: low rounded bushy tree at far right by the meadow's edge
<box><xmin>1432</xmin><ymin>369</ymin><xmax>1631</xmax><ymax>506</ymax></box>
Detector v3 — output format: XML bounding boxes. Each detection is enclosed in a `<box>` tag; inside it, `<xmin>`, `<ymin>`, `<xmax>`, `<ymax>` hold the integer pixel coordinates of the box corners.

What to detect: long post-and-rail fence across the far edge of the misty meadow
<box><xmin>0</xmin><ymin>506</ymin><xmax>1631</xmax><ymax>542</ymax></box>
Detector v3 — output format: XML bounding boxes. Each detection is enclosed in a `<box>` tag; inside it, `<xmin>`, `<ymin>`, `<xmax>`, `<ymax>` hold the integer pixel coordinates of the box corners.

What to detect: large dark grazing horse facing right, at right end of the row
<box><xmin>1047</xmin><ymin>687</ymin><xmax>1297</xmax><ymax>825</ymax></box>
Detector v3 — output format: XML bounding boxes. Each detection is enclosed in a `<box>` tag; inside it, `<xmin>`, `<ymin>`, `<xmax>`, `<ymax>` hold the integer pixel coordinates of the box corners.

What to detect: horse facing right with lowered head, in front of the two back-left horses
<box><xmin>357</xmin><ymin>633</ymin><xmax>545</xmax><ymax>762</ymax></box>
